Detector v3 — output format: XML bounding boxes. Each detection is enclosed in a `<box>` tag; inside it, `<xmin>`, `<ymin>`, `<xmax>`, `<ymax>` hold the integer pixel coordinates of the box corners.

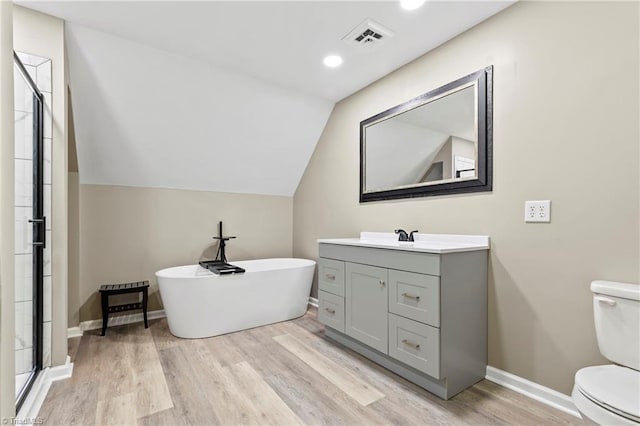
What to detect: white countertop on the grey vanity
<box><xmin>318</xmin><ymin>232</ymin><xmax>489</xmax><ymax>254</ymax></box>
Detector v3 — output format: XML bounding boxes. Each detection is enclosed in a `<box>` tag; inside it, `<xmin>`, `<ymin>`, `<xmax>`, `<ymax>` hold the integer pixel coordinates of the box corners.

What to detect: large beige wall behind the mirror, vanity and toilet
<box><xmin>293</xmin><ymin>2</ymin><xmax>640</xmax><ymax>394</ymax></box>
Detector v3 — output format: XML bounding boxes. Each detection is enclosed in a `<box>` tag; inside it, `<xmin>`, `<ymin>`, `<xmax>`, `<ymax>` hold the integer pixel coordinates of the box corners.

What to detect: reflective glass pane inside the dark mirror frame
<box><xmin>365</xmin><ymin>85</ymin><xmax>478</xmax><ymax>192</ymax></box>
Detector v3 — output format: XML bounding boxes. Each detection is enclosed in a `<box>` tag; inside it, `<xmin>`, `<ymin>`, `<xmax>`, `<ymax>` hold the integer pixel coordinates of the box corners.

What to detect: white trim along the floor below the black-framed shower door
<box><xmin>13</xmin><ymin>356</ymin><xmax>73</xmax><ymax>424</ymax></box>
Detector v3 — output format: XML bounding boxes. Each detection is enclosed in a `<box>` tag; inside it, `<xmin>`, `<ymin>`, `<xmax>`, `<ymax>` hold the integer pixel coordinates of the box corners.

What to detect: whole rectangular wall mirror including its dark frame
<box><xmin>360</xmin><ymin>66</ymin><xmax>493</xmax><ymax>202</ymax></box>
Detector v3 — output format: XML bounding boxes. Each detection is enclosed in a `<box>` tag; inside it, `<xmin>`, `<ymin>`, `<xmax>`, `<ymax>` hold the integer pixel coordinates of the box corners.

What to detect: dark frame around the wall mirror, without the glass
<box><xmin>360</xmin><ymin>66</ymin><xmax>493</xmax><ymax>203</ymax></box>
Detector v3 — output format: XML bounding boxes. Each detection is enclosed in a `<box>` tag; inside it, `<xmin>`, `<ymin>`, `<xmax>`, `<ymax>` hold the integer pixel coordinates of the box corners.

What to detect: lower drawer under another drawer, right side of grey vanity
<box><xmin>389</xmin><ymin>314</ymin><xmax>440</xmax><ymax>379</ymax></box>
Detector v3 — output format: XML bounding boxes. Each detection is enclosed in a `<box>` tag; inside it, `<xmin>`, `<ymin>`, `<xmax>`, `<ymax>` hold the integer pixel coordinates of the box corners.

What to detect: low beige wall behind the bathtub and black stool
<box><xmin>76</xmin><ymin>185</ymin><xmax>293</xmax><ymax>321</ymax></box>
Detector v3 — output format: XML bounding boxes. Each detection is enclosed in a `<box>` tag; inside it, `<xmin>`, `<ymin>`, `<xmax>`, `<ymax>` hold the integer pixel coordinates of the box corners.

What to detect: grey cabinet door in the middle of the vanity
<box><xmin>345</xmin><ymin>263</ymin><xmax>388</xmax><ymax>354</ymax></box>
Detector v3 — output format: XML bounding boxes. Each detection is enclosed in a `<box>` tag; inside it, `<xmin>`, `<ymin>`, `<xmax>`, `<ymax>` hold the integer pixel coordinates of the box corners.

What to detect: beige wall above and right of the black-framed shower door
<box><xmin>13</xmin><ymin>6</ymin><xmax>67</xmax><ymax>366</ymax></box>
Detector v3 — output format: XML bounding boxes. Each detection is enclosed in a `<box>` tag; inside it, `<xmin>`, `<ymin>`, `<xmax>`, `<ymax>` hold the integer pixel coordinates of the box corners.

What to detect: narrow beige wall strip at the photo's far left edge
<box><xmin>0</xmin><ymin>1</ymin><xmax>15</xmax><ymax>419</ymax></box>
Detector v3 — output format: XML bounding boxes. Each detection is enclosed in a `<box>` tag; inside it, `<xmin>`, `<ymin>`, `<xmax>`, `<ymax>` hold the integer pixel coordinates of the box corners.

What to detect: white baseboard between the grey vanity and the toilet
<box><xmin>486</xmin><ymin>366</ymin><xmax>580</xmax><ymax>418</ymax></box>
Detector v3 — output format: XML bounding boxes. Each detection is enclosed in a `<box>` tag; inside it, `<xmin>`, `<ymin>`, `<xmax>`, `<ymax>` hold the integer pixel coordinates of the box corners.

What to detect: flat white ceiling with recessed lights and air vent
<box><xmin>17</xmin><ymin>0</ymin><xmax>515</xmax><ymax>102</ymax></box>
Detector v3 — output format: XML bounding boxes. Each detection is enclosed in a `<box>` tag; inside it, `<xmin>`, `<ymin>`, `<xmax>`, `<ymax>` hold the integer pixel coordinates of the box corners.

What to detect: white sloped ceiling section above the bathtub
<box><xmin>67</xmin><ymin>24</ymin><xmax>333</xmax><ymax>196</ymax></box>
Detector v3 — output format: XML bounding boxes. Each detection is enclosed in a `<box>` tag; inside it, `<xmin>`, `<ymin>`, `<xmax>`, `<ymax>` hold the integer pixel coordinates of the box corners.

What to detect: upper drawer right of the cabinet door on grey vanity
<box><xmin>389</xmin><ymin>269</ymin><xmax>440</xmax><ymax>327</ymax></box>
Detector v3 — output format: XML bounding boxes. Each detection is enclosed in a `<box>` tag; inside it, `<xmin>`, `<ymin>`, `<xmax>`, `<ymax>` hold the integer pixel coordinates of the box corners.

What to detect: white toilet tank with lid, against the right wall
<box><xmin>591</xmin><ymin>281</ymin><xmax>640</xmax><ymax>370</ymax></box>
